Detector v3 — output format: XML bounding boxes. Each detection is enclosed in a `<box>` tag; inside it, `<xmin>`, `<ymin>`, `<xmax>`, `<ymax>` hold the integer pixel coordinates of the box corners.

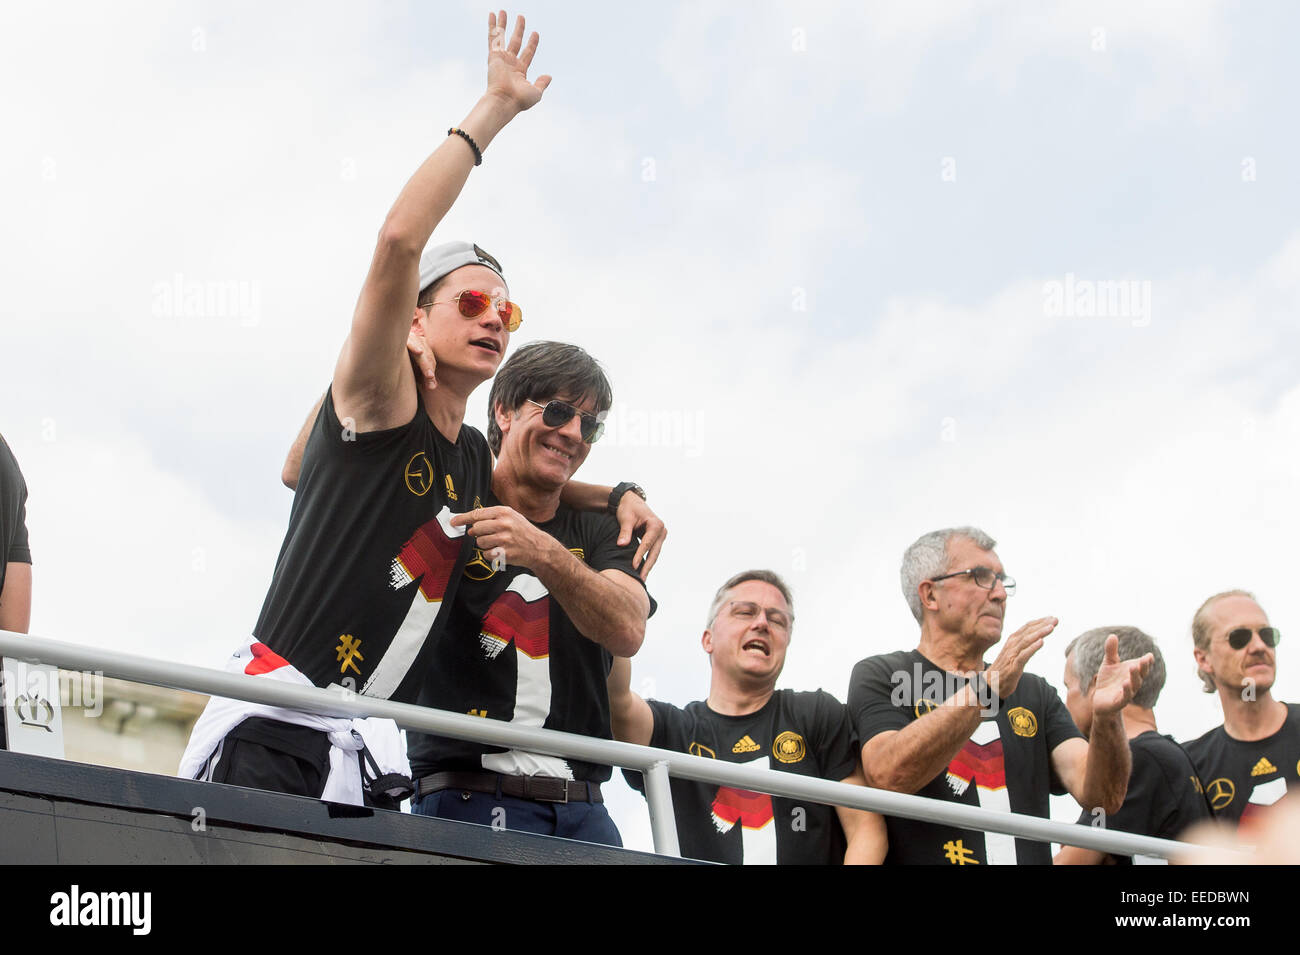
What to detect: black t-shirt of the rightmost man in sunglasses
<box><xmin>1183</xmin><ymin>703</ymin><xmax>1300</xmax><ymax>828</ymax></box>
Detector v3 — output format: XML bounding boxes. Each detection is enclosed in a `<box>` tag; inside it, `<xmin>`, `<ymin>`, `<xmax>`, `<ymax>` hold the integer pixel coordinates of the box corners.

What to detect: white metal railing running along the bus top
<box><xmin>0</xmin><ymin>630</ymin><xmax>1248</xmax><ymax>861</ymax></box>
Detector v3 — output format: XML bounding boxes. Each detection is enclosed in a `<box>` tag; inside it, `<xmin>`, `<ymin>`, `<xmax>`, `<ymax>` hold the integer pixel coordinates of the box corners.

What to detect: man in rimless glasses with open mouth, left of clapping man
<box><xmin>610</xmin><ymin>570</ymin><xmax>885</xmax><ymax>865</ymax></box>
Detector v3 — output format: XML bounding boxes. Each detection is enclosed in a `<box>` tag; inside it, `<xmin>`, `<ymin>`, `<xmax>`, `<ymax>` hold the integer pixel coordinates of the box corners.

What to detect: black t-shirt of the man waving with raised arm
<box><xmin>254</xmin><ymin>392</ymin><xmax>491</xmax><ymax>700</ymax></box>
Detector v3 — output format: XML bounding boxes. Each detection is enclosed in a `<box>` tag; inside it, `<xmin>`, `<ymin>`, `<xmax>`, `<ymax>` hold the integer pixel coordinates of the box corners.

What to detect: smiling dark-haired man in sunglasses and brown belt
<box><xmin>407</xmin><ymin>342</ymin><xmax>654</xmax><ymax>846</ymax></box>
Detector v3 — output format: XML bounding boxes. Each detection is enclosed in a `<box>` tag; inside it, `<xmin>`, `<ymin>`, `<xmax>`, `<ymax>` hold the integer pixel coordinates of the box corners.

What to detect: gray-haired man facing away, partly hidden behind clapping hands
<box><xmin>1053</xmin><ymin>626</ymin><xmax>1209</xmax><ymax>865</ymax></box>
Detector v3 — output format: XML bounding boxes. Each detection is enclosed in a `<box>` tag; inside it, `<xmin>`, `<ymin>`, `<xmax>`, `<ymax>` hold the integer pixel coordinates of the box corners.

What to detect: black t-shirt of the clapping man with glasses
<box><xmin>849</xmin><ymin>650</ymin><xmax>1083</xmax><ymax>865</ymax></box>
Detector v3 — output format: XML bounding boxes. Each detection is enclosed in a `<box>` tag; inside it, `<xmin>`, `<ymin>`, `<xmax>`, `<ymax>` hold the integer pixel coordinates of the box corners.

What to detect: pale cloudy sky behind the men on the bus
<box><xmin>0</xmin><ymin>0</ymin><xmax>1300</xmax><ymax>845</ymax></box>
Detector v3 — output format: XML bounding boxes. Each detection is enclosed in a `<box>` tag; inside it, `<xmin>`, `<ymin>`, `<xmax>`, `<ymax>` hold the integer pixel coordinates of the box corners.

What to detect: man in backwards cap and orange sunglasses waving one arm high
<box><xmin>178</xmin><ymin>14</ymin><xmax>653</xmax><ymax>807</ymax></box>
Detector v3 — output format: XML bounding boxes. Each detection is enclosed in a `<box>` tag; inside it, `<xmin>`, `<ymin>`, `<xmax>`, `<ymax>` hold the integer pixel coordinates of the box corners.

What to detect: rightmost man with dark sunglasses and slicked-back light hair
<box><xmin>1183</xmin><ymin>590</ymin><xmax>1300</xmax><ymax>830</ymax></box>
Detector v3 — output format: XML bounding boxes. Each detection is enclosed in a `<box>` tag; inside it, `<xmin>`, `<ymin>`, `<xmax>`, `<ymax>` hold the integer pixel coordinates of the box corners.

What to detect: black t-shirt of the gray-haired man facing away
<box><xmin>1079</xmin><ymin>730</ymin><xmax>1210</xmax><ymax>864</ymax></box>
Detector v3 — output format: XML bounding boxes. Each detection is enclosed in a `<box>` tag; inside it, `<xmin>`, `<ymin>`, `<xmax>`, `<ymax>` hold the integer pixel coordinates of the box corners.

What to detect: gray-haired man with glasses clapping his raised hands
<box><xmin>849</xmin><ymin>528</ymin><xmax>1151</xmax><ymax>865</ymax></box>
